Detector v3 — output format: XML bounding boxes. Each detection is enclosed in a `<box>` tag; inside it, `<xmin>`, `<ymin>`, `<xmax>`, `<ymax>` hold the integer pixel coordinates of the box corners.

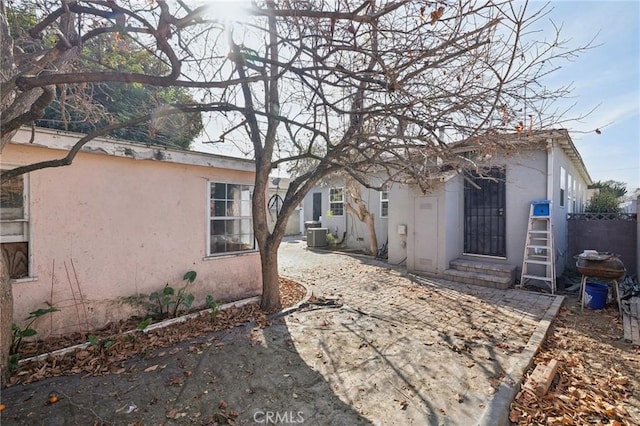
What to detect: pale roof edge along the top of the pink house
<box><xmin>10</xmin><ymin>127</ymin><xmax>255</xmax><ymax>172</ymax></box>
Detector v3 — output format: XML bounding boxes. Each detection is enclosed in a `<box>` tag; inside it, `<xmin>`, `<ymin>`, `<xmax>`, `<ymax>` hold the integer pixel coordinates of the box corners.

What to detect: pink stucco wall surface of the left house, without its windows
<box><xmin>1</xmin><ymin>140</ymin><xmax>261</xmax><ymax>336</ymax></box>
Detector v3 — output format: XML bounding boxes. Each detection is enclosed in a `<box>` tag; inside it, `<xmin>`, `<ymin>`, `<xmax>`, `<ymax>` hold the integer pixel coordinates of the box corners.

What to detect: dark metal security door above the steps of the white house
<box><xmin>464</xmin><ymin>168</ymin><xmax>507</xmax><ymax>257</ymax></box>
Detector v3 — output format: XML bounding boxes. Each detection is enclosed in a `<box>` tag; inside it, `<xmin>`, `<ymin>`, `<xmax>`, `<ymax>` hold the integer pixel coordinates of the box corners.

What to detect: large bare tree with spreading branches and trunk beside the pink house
<box><xmin>0</xmin><ymin>0</ymin><xmax>592</xmax><ymax>380</ymax></box>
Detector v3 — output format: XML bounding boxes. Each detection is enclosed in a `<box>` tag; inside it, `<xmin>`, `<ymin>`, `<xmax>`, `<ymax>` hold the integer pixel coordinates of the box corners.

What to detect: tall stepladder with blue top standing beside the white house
<box><xmin>520</xmin><ymin>200</ymin><xmax>556</xmax><ymax>294</ymax></box>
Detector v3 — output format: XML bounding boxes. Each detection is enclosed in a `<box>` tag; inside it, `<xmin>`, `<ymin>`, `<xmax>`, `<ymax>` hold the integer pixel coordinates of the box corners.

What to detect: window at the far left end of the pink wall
<box><xmin>0</xmin><ymin>175</ymin><xmax>29</xmax><ymax>278</ymax></box>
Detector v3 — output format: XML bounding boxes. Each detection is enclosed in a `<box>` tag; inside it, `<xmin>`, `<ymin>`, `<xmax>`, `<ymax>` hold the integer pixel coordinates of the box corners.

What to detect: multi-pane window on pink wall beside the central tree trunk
<box><xmin>208</xmin><ymin>182</ymin><xmax>256</xmax><ymax>255</ymax></box>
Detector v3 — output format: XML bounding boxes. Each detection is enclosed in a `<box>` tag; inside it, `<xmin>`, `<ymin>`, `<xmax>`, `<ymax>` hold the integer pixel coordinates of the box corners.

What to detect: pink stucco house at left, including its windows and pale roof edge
<box><xmin>0</xmin><ymin>129</ymin><xmax>261</xmax><ymax>336</ymax></box>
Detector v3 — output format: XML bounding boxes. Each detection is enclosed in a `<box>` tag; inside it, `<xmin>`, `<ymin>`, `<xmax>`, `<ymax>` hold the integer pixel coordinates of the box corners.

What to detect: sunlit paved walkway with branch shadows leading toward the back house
<box><xmin>280</xmin><ymin>240</ymin><xmax>563</xmax><ymax>425</ymax></box>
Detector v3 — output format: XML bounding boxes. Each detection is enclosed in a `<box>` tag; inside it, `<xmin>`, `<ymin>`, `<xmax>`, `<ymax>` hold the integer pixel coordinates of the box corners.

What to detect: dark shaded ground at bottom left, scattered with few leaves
<box><xmin>2</xmin><ymin>319</ymin><xmax>370</xmax><ymax>425</ymax></box>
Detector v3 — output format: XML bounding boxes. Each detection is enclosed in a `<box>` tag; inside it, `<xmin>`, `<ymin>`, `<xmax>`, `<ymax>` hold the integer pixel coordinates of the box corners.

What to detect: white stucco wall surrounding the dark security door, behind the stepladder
<box><xmin>400</xmin><ymin>136</ymin><xmax>587</xmax><ymax>282</ymax></box>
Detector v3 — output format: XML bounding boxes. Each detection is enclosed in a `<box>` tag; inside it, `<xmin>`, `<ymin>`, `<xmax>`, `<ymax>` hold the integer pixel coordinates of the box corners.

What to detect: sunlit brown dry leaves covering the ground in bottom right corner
<box><xmin>510</xmin><ymin>302</ymin><xmax>640</xmax><ymax>425</ymax></box>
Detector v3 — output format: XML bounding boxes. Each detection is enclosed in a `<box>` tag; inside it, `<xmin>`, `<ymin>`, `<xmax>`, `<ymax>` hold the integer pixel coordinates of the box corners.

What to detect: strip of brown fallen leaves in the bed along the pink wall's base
<box><xmin>8</xmin><ymin>278</ymin><xmax>306</xmax><ymax>386</ymax></box>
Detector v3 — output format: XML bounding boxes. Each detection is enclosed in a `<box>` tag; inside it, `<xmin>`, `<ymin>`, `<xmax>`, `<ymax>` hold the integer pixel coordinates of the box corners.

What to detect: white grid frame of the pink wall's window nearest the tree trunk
<box><xmin>205</xmin><ymin>180</ymin><xmax>258</xmax><ymax>257</ymax></box>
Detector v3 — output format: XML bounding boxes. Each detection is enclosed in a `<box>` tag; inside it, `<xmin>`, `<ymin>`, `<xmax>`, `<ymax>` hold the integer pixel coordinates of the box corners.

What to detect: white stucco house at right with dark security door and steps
<box><xmin>304</xmin><ymin>129</ymin><xmax>592</xmax><ymax>288</ymax></box>
